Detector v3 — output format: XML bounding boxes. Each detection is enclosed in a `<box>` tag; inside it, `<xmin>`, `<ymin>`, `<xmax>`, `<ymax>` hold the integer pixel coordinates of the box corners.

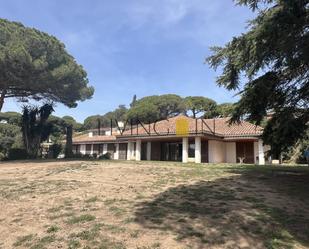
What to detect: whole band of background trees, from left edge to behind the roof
<box><xmin>0</xmin><ymin>94</ymin><xmax>234</xmax><ymax>160</ymax></box>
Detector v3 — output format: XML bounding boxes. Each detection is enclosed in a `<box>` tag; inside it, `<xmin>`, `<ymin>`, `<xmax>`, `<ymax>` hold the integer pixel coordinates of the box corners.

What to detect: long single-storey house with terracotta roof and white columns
<box><xmin>73</xmin><ymin>115</ymin><xmax>269</xmax><ymax>164</ymax></box>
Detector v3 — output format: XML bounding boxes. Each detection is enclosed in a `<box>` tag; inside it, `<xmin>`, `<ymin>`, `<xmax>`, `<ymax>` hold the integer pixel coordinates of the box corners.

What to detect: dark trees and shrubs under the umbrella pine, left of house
<box><xmin>0</xmin><ymin>110</ymin><xmax>84</xmax><ymax>160</ymax></box>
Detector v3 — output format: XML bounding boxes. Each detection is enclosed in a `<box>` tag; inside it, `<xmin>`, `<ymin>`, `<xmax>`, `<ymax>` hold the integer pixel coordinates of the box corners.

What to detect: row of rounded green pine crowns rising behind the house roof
<box><xmin>83</xmin><ymin>94</ymin><xmax>234</xmax><ymax>129</ymax></box>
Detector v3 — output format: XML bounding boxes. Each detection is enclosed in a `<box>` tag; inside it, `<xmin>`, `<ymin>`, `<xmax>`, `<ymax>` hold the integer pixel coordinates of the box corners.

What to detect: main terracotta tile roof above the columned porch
<box><xmin>117</xmin><ymin>115</ymin><xmax>262</xmax><ymax>137</ymax></box>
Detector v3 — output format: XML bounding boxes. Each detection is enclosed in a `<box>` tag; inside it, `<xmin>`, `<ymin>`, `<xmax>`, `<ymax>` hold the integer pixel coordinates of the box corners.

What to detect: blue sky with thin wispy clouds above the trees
<box><xmin>0</xmin><ymin>0</ymin><xmax>253</xmax><ymax>121</ymax></box>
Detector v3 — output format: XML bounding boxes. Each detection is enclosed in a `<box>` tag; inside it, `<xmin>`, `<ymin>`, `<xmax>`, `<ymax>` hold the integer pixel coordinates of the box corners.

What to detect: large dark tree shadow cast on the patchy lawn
<box><xmin>135</xmin><ymin>168</ymin><xmax>309</xmax><ymax>248</ymax></box>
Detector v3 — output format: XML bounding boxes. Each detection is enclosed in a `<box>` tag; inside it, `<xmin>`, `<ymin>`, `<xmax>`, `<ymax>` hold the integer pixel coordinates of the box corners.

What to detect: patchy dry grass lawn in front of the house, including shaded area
<box><xmin>0</xmin><ymin>161</ymin><xmax>309</xmax><ymax>249</ymax></box>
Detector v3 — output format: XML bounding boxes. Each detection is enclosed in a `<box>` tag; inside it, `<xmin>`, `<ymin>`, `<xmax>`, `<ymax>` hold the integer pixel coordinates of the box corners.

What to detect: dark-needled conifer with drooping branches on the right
<box><xmin>207</xmin><ymin>0</ymin><xmax>309</xmax><ymax>156</ymax></box>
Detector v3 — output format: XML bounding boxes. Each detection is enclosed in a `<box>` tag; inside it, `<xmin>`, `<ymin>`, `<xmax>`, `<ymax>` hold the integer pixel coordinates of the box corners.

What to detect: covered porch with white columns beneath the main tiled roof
<box><xmin>127</xmin><ymin>136</ymin><xmax>265</xmax><ymax>164</ymax></box>
